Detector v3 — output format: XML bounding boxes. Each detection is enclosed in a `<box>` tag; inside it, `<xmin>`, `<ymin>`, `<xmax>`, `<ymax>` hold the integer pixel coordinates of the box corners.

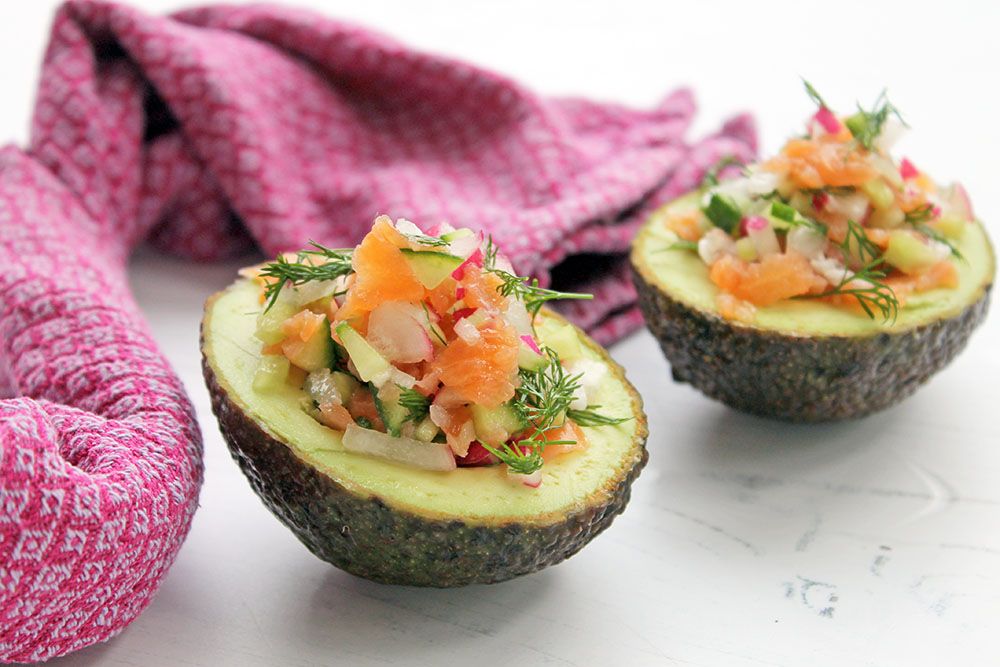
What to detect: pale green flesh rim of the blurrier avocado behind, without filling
<box><xmin>634</xmin><ymin>193</ymin><xmax>994</xmax><ymax>336</ymax></box>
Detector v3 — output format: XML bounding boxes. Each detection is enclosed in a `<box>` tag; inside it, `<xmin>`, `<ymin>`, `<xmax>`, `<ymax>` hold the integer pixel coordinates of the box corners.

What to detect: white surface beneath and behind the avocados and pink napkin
<box><xmin>0</xmin><ymin>0</ymin><xmax>1000</xmax><ymax>667</ymax></box>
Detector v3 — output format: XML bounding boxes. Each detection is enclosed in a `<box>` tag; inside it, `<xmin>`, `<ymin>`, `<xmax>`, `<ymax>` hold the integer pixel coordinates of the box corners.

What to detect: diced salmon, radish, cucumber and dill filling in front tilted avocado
<box><xmin>243</xmin><ymin>216</ymin><xmax>628</xmax><ymax>486</ymax></box>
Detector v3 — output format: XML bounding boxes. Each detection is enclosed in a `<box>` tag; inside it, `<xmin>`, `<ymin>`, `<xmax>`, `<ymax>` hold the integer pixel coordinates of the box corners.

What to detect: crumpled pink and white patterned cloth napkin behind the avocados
<box><xmin>0</xmin><ymin>0</ymin><xmax>754</xmax><ymax>661</ymax></box>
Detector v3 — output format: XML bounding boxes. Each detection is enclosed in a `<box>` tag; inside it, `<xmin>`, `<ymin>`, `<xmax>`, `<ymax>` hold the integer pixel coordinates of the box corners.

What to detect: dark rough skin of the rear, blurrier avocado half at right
<box><xmin>632</xmin><ymin>264</ymin><xmax>992</xmax><ymax>422</ymax></box>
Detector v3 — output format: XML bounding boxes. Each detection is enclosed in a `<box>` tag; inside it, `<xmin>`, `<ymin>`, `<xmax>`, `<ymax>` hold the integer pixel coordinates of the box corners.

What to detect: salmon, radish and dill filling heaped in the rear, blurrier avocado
<box><xmin>664</xmin><ymin>83</ymin><xmax>973</xmax><ymax>323</ymax></box>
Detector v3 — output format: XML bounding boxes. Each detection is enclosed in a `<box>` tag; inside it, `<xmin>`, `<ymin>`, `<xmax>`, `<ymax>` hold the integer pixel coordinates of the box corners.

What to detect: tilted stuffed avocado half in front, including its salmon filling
<box><xmin>202</xmin><ymin>216</ymin><xmax>647</xmax><ymax>587</ymax></box>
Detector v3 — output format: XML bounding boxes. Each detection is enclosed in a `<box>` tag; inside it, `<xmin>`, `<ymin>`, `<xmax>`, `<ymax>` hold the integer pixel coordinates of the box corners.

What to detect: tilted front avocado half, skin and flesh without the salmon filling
<box><xmin>201</xmin><ymin>280</ymin><xmax>647</xmax><ymax>587</ymax></box>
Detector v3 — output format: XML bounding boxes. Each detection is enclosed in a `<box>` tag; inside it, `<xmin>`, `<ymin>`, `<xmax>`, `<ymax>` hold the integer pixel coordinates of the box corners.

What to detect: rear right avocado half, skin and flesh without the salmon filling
<box><xmin>631</xmin><ymin>192</ymin><xmax>995</xmax><ymax>422</ymax></box>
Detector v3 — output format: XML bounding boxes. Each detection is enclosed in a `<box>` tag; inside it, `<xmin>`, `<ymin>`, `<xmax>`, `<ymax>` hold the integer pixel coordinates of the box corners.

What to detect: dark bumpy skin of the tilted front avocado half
<box><xmin>202</xmin><ymin>320</ymin><xmax>648</xmax><ymax>588</ymax></box>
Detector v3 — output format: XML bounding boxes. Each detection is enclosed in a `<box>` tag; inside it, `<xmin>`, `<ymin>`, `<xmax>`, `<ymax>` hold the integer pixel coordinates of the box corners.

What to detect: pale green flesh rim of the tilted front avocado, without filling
<box><xmin>203</xmin><ymin>281</ymin><xmax>645</xmax><ymax>525</ymax></box>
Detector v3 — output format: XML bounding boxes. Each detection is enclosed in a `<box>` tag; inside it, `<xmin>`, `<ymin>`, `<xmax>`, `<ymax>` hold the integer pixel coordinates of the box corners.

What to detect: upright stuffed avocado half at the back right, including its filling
<box><xmin>631</xmin><ymin>84</ymin><xmax>995</xmax><ymax>421</ymax></box>
